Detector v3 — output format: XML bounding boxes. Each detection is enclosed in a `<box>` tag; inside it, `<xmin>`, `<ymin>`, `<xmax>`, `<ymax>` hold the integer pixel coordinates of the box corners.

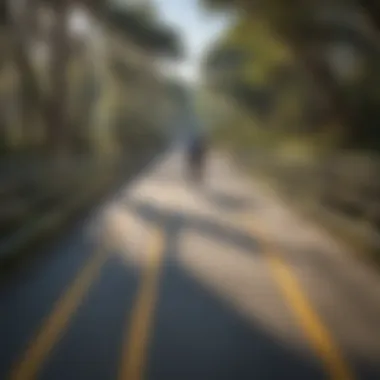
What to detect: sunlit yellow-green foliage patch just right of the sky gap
<box><xmin>205</xmin><ymin>11</ymin><xmax>314</xmax><ymax>131</ymax></box>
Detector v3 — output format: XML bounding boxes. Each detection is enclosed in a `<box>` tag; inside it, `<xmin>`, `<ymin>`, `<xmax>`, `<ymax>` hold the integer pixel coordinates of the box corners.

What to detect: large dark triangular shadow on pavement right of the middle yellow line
<box><xmin>147</xmin><ymin>262</ymin><xmax>323</xmax><ymax>380</ymax></box>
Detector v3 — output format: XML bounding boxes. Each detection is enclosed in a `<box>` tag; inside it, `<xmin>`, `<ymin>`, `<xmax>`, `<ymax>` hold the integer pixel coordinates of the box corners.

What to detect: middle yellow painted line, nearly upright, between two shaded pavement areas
<box><xmin>119</xmin><ymin>226</ymin><xmax>164</xmax><ymax>380</ymax></box>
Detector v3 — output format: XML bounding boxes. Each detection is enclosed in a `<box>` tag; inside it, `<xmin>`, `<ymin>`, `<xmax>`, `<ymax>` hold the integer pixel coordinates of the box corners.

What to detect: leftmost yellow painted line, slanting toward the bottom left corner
<box><xmin>9</xmin><ymin>246</ymin><xmax>107</xmax><ymax>380</ymax></box>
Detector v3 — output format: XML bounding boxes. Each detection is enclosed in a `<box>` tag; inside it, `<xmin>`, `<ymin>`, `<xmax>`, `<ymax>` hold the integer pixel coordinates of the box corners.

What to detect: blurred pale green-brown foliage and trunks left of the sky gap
<box><xmin>0</xmin><ymin>0</ymin><xmax>181</xmax><ymax>157</ymax></box>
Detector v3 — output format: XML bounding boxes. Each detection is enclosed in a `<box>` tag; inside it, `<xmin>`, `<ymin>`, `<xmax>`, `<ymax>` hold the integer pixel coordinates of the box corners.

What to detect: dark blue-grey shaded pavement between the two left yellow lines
<box><xmin>40</xmin><ymin>252</ymin><xmax>139</xmax><ymax>380</ymax></box>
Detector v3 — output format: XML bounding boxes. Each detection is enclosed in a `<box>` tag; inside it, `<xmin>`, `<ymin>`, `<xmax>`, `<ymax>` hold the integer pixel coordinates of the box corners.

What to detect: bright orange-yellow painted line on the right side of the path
<box><xmin>251</xmin><ymin>221</ymin><xmax>355</xmax><ymax>380</ymax></box>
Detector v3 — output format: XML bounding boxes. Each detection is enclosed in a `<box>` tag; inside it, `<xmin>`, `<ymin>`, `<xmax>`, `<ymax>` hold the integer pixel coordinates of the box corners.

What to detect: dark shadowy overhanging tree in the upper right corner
<box><xmin>203</xmin><ymin>0</ymin><xmax>380</xmax><ymax>148</ymax></box>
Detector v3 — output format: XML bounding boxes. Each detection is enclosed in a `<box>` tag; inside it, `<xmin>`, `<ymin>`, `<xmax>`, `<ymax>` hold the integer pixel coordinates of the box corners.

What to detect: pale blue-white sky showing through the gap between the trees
<box><xmin>153</xmin><ymin>0</ymin><xmax>228</xmax><ymax>82</ymax></box>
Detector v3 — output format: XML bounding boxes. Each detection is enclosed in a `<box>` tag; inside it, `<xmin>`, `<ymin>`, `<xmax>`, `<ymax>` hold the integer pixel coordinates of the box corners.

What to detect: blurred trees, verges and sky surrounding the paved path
<box><xmin>0</xmin><ymin>0</ymin><xmax>380</xmax><ymax>266</ymax></box>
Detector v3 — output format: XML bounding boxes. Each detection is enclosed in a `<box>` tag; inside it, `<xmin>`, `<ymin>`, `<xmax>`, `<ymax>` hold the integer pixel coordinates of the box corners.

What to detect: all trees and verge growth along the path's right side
<box><xmin>200</xmin><ymin>0</ymin><xmax>380</xmax><ymax>259</ymax></box>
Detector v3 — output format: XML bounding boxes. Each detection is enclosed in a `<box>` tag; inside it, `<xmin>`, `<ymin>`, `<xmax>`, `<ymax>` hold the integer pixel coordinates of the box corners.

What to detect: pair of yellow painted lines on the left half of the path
<box><xmin>9</xmin><ymin>224</ymin><xmax>163</xmax><ymax>380</ymax></box>
